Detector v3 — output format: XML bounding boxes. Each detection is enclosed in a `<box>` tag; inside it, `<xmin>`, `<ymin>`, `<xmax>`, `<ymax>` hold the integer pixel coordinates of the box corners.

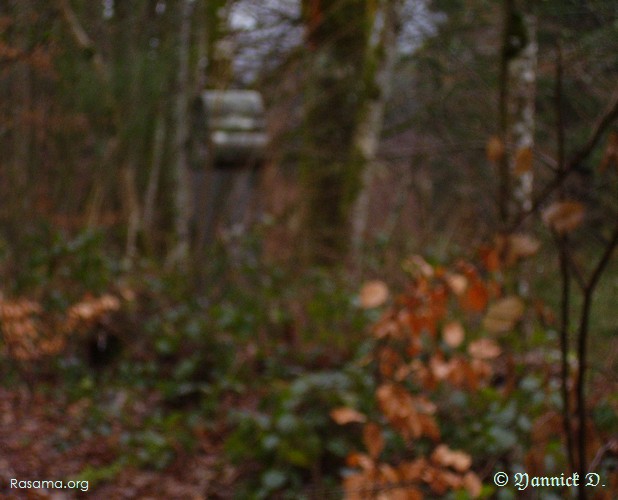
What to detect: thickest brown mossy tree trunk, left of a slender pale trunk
<box><xmin>302</xmin><ymin>0</ymin><xmax>370</xmax><ymax>265</ymax></box>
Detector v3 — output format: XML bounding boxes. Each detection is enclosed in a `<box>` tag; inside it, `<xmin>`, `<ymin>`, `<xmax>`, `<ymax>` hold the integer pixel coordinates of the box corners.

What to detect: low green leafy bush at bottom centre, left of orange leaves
<box><xmin>226</xmin><ymin>365</ymin><xmax>373</xmax><ymax>499</ymax></box>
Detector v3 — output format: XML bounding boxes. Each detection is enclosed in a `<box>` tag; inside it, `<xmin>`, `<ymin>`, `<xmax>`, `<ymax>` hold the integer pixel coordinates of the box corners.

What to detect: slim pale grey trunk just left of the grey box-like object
<box><xmin>167</xmin><ymin>0</ymin><xmax>193</xmax><ymax>267</ymax></box>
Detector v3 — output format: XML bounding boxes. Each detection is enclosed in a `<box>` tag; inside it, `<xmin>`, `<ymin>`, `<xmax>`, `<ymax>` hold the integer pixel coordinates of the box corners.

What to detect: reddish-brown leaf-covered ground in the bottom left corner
<box><xmin>0</xmin><ymin>388</ymin><xmax>236</xmax><ymax>500</ymax></box>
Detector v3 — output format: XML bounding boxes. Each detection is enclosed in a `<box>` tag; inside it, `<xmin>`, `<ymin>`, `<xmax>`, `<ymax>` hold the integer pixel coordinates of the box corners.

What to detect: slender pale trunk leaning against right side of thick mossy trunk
<box><xmin>351</xmin><ymin>0</ymin><xmax>400</xmax><ymax>272</ymax></box>
